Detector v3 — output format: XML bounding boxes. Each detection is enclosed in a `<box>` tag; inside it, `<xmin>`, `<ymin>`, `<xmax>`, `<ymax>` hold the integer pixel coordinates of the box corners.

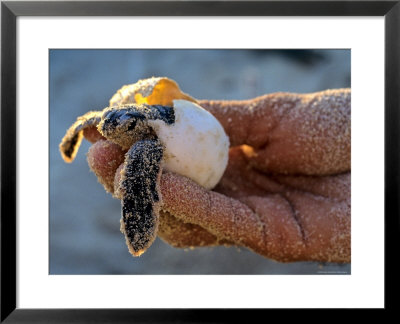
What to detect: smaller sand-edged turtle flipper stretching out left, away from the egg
<box><xmin>59</xmin><ymin>111</ymin><xmax>102</xmax><ymax>163</ymax></box>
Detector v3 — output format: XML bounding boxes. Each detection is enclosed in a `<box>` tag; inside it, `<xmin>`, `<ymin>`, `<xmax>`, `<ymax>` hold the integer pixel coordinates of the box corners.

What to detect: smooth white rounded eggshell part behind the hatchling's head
<box><xmin>149</xmin><ymin>100</ymin><xmax>229</xmax><ymax>189</ymax></box>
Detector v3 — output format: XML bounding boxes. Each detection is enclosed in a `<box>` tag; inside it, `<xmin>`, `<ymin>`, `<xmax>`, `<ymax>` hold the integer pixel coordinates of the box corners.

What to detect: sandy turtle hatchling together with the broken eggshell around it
<box><xmin>60</xmin><ymin>78</ymin><xmax>229</xmax><ymax>256</ymax></box>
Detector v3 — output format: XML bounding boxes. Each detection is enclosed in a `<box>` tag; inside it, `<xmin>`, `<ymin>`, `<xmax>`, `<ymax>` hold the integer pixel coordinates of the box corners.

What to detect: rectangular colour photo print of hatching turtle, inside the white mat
<box><xmin>49</xmin><ymin>48</ymin><xmax>351</xmax><ymax>275</ymax></box>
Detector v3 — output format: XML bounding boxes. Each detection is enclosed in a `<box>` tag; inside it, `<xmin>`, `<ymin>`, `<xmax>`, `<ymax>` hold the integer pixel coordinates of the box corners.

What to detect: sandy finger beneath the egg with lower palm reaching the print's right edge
<box><xmin>161</xmin><ymin>173</ymin><xmax>350</xmax><ymax>262</ymax></box>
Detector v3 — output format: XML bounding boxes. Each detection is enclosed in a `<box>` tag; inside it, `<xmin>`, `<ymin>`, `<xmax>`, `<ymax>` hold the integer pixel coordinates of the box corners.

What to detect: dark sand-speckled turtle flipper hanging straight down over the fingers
<box><xmin>120</xmin><ymin>136</ymin><xmax>163</xmax><ymax>256</ymax></box>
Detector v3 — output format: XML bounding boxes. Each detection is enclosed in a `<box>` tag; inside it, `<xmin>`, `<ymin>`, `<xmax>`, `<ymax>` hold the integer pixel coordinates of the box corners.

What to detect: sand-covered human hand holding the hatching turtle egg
<box><xmin>84</xmin><ymin>89</ymin><xmax>351</xmax><ymax>262</ymax></box>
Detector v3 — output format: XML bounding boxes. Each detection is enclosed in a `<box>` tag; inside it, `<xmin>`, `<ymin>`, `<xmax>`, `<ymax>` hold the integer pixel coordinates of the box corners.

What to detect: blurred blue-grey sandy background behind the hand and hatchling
<box><xmin>49</xmin><ymin>50</ymin><xmax>350</xmax><ymax>274</ymax></box>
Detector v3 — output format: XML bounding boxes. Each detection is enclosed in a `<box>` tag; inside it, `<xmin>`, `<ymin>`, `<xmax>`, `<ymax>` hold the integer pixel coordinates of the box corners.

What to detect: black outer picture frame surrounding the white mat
<box><xmin>0</xmin><ymin>0</ymin><xmax>400</xmax><ymax>323</ymax></box>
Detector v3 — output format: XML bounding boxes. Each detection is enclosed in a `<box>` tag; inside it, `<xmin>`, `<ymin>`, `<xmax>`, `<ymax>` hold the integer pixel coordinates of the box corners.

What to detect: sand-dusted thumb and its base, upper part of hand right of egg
<box><xmin>200</xmin><ymin>89</ymin><xmax>351</xmax><ymax>175</ymax></box>
